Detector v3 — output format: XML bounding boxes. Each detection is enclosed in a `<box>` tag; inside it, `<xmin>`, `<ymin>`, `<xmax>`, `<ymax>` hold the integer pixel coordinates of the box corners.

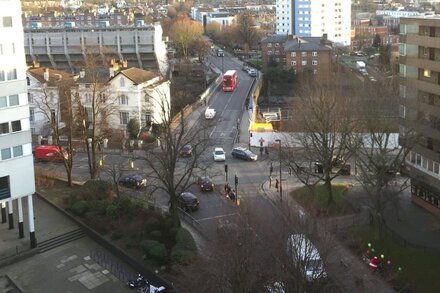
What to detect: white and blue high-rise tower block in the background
<box><xmin>276</xmin><ymin>0</ymin><xmax>351</xmax><ymax>46</ymax></box>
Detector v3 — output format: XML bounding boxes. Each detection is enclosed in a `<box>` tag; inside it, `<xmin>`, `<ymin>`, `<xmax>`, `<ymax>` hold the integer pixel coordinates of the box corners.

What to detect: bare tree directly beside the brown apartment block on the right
<box><xmin>354</xmin><ymin>80</ymin><xmax>418</xmax><ymax>237</ymax></box>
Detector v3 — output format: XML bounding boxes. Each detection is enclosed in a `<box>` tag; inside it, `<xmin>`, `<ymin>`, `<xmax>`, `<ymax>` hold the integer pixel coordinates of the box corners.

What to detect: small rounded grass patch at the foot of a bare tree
<box><xmin>293</xmin><ymin>184</ymin><xmax>353</xmax><ymax>217</ymax></box>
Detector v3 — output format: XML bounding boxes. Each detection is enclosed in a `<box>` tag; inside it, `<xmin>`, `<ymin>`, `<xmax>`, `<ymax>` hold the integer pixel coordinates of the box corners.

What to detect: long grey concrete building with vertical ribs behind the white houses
<box><xmin>24</xmin><ymin>23</ymin><xmax>168</xmax><ymax>75</ymax></box>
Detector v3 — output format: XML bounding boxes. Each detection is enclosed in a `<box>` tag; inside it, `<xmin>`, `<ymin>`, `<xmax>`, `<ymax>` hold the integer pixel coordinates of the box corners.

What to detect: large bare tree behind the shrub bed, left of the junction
<box><xmin>144</xmin><ymin>81</ymin><xmax>209</xmax><ymax>227</ymax></box>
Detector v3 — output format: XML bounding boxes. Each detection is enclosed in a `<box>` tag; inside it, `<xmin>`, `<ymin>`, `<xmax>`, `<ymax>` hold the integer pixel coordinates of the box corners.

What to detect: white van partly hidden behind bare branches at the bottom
<box><xmin>287</xmin><ymin>234</ymin><xmax>327</xmax><ymax>281</ymax></box>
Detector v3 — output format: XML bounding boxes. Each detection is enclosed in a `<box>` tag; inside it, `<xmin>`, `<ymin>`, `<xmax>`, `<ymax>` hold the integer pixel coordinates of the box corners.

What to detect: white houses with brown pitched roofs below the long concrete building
<box><xmin>27</xmin><ymin>68</ymin><xmax>171</xmax><ymax>136</ymax></box>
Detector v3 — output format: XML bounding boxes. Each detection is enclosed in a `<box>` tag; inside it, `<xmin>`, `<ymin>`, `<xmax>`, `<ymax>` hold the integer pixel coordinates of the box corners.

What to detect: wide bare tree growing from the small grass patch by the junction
<box><xmin>283</xmin><ymin>80</ymin><xmax>355</xmax><ymax>204</ymax></box>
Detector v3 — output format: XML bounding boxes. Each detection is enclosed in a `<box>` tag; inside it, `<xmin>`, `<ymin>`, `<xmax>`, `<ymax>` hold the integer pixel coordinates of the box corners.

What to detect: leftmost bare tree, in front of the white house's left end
<box><xmin>35</xmin><ymin>78</ymin><xmax>74</xmax><ymax>186</ymax></box>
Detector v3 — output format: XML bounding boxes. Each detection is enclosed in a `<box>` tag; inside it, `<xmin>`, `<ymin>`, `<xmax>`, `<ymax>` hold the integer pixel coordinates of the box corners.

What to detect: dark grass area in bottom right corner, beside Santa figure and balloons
<box><xmin>343</xmin><ymin>226</ymin><xmax>440</xmax><ymax>292</ymax></box>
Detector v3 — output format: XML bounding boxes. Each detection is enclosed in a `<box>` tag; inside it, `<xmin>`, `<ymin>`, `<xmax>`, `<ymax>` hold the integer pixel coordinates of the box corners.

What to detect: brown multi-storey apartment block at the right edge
<box><xmin>399</xmin><ymin>15</ymin><xmax>440</xmax><ymax>215</ymax></box>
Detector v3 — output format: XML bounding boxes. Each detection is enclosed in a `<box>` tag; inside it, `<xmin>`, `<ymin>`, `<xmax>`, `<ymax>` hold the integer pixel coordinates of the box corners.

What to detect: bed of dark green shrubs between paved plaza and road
<box><xmin>36</xmin><ymin>168</ymin><xmax>197</xmax><ymax>272</ymax></box>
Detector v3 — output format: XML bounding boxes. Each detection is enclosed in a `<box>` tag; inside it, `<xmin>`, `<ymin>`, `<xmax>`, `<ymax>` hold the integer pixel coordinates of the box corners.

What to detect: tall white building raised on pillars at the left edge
<box><xmin>0</xmin><ymin>0</ymin><xmax>37</xmax><ymax>248</ymax></box>
